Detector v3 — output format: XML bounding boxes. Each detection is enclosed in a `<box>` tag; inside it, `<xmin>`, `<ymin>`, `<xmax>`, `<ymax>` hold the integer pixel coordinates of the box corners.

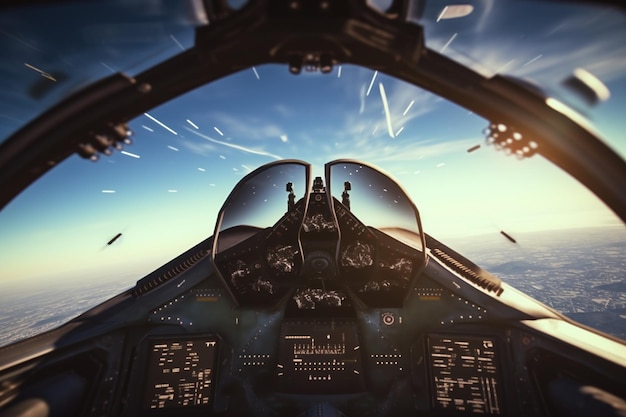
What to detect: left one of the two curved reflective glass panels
<box><xmin>211</xmin><ymin>160</ymin><xmax>310</xmax><ymax>304</ymax></box>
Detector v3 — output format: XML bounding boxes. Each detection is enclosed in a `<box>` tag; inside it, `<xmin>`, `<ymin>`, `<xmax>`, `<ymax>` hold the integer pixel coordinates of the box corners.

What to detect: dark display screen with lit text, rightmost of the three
<box><xmin>427</xmin><ymin>335</ymin><xmax>502</xmax><ymax>415</ymax></box>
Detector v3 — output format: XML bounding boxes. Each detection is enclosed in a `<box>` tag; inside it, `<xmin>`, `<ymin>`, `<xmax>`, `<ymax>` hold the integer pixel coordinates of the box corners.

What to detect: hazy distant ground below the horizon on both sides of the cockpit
<box><xmin>0</xmin><ymin>227</ymin><xmax>626</xmax><ymax>346</ymax></box>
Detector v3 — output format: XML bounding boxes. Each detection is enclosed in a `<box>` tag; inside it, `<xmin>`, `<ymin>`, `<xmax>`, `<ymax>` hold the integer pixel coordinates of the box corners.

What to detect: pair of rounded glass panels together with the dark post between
<box><xmin>212</xmin><ymin>160</ymin><xmax>426</xmax><ymax>309</ymax></box>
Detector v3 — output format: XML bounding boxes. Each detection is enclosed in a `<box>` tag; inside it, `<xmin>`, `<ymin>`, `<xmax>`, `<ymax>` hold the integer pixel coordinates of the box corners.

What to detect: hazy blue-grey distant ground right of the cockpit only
<box><xmin>453</xmin><ymin>227</ymin><xmax>626</xmax><ymax>340</ymax></box>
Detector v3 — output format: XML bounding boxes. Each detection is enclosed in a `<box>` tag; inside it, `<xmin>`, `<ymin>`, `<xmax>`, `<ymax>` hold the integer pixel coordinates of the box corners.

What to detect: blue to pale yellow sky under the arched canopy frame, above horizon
<box><xmin>0</xmin><ymin>66</ymin><xmax>619</xmax><ymax>286</ymax></box>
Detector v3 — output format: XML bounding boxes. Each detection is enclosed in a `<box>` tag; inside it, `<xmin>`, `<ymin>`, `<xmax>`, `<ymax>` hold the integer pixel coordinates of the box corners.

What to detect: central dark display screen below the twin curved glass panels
<box><xmin>277</xmin><ymin>320</ymin><xmax>364</xmax><ymax>394</ymax></box>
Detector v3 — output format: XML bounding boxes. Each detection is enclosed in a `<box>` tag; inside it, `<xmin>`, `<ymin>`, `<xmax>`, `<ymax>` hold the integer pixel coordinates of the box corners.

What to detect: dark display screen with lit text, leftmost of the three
<box><xmin>144</xmin><ymin>337</ymin><xmax>218</xmax><ymax>410</ymax></box>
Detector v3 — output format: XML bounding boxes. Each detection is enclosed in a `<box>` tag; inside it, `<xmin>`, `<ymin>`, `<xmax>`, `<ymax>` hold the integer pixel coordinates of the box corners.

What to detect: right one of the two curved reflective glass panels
<box><xmin>325</xmin><ymin>160</ymin><xmax>426</xmax><ymax>306</ymax></box>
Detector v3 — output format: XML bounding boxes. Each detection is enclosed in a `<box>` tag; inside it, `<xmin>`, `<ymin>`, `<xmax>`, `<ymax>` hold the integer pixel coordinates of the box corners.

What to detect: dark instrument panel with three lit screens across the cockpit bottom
<box><xmin>121</xmin><ymin>256</ymin><xmax>512</xmax><ymax>417</ymax></box>
